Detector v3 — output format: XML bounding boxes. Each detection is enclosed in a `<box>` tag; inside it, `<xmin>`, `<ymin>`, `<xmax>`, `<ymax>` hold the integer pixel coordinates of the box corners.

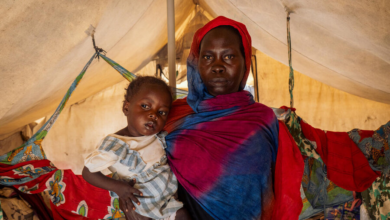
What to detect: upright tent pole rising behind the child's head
<box><xmin>167</xmin><ymin>0</ymin><xmax>176</xmax><ymax>88</ymax></box>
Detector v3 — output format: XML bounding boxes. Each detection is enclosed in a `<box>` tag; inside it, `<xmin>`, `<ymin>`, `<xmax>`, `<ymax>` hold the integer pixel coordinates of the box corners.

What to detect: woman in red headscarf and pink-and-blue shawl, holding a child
<box><xmin>165</xmin><ymin>17</ymin><xmax>303</xmax><ymax>220</ymax></box>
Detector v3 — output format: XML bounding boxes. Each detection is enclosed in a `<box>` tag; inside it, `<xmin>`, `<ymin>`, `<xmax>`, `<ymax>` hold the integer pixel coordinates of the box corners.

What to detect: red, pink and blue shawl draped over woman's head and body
<box><xmin>166</xmin><ymin>17</ymin><xmax>303</xmax><ymax>220</ymax></box>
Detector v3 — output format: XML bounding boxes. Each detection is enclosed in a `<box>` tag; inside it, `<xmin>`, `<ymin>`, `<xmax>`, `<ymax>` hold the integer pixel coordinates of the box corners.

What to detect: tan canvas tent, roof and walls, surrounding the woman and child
<box><xmin>0</xmin><ymin>0</ymin><xmax>390</xmax><ymax>218</ymax></box>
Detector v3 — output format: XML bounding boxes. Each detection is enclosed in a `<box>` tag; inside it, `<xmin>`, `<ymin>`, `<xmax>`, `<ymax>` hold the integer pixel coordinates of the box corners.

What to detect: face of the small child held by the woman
<box><xmin>123</xmin><ymin>84</ymin><xmax>172</xmax><ymax>137</ymax></box>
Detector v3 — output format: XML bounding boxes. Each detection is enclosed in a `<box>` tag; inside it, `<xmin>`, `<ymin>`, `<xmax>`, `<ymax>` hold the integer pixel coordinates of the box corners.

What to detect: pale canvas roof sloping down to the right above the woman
<box><xmin>199</xmin><ymin>0</ymin><xmax>390</xmax><ymax>104</ymax></box>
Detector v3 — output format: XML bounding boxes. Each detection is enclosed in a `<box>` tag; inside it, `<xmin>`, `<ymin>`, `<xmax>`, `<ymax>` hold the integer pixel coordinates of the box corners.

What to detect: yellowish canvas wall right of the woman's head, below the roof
<box><xmin>256</xmin><ymin>51</ymin><xmax>390</xmax><ymax>131</ymax></box>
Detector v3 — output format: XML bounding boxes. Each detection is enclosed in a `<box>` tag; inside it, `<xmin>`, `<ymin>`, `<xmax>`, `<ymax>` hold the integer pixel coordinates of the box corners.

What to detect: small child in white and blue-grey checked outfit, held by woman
<box><xmin>82</xmin><ymin>76</ymin><xmax>187</xmax><ymax>220</ymax></box>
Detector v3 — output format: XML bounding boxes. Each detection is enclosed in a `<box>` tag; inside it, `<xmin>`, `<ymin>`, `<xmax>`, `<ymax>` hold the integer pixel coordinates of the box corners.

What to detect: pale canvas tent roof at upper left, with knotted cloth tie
<box><xmin>0</xmin><ymin>0</ymin><xmax>195</xmax><ymax>134</ymax></box>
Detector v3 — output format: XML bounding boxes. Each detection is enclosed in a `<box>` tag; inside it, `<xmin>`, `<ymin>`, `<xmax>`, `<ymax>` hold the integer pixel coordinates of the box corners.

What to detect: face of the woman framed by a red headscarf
<box><xmin>198</xmin><ymin>27</ymin><xmax>245</xmax><ymax>96</ymax></box>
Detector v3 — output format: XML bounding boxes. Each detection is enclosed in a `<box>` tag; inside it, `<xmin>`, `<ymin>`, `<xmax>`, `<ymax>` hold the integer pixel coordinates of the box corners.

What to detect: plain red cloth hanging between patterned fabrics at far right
<box><xmin>301</xmin><ymin>120</ymin><xmax>379</xmax><ymax>192</ymax></box>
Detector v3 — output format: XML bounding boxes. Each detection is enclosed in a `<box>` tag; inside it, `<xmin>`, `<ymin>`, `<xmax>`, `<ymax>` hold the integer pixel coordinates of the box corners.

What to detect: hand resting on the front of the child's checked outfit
<box><xmin>114</xmin><ymin>179</ymin><xmax>142</xmax><ymax>212</ymax></box>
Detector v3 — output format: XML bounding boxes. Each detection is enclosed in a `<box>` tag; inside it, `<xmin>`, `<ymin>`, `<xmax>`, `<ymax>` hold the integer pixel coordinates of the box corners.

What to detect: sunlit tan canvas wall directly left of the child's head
<box><xmin>42</xmin><ymin>81</ymin><xmax>128</xmax><ymax>174</ymax></box>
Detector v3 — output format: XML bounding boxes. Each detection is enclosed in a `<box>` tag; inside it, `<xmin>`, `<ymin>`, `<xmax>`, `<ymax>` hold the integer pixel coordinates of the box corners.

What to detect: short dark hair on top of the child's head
<box><xmin>125</xmin><ymin>76</ymin><xmax>172</xmax><ymax>102</ymax></box>
